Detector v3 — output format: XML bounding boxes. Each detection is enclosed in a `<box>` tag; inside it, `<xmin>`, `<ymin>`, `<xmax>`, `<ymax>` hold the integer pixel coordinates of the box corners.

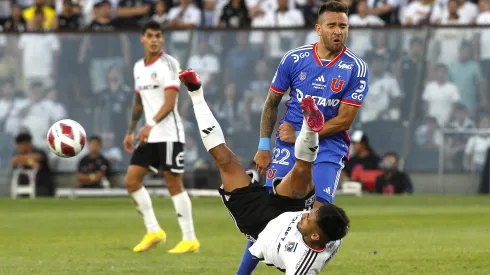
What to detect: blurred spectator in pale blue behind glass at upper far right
<box><xmin>449</xmin><ymin>41</ymin><xmax>487</xmax><ymax>114</ymax></box>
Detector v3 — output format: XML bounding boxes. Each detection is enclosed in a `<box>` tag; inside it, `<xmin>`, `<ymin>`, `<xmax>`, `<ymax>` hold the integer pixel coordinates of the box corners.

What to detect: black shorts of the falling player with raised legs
<box><xmin>219</xmin><ymin>183</ymin><xmax>315</xmax><ymax>241</ymax></box>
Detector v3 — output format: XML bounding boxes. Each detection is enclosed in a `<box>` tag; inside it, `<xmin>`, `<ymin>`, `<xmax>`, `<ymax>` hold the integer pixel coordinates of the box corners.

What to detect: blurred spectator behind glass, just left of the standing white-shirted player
<box><xmin>95</xmin><ymin>66</ymin><xmax>133</xmax><ymax>144</ymax></box>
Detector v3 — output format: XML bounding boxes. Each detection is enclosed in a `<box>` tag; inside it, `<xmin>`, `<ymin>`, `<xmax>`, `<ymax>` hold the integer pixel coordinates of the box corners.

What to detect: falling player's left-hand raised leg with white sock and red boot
<box><xmin>179</xmin><ymin>69</ymin><xmax>251</xmax><ymax>192</ymax></box>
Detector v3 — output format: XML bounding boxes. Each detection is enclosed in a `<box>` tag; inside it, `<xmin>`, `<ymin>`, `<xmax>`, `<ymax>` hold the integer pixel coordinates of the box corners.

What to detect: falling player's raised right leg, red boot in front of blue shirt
<box><xmin>276</xmin><ymin>97</ymin><xmax>324</xmax><ymax>199</ymax></box>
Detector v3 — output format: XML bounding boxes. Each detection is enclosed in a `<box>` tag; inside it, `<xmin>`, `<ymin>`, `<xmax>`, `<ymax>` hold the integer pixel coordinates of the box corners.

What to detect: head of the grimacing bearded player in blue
<box><xmin>315</xmin><ymin>0</ymin><xmax>349</xmax><ymax>53</ymax></box>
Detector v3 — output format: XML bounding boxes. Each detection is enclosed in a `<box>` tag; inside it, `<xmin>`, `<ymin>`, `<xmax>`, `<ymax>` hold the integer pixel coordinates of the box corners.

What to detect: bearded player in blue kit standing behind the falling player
<box><xmin>237</xmin><ymin>0</ymin><xmax>368</xmax><ymax>275</ymax></box>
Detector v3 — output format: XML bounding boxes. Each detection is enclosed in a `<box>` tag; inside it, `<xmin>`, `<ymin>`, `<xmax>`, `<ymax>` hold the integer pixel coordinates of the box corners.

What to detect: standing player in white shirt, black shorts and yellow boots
<box><xmin>124</xmin><ymin>21</ymin><xmax>200</xmax><ymax>254</ymax></box>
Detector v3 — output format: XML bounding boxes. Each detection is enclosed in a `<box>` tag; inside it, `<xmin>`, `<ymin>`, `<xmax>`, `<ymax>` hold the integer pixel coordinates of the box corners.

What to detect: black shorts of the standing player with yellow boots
<box><xmin>131</xmin><ymin>142</ymin><xmax>184</xmax><ymax>174</ymax></box>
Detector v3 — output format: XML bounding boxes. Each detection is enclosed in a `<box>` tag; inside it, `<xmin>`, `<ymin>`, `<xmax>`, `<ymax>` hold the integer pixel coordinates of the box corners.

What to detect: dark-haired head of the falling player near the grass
<box><xmin>298</xmin><ymin>204</ymin><xmax>350</xmax><ymax>247</ymax></box>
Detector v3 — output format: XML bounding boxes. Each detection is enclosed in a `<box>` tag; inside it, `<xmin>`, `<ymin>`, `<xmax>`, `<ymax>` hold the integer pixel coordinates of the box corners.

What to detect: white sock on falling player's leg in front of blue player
<box><xmin>294</xmin><ymin>119</ymin><xmax>318</xmax><ymax>162</ymax></box>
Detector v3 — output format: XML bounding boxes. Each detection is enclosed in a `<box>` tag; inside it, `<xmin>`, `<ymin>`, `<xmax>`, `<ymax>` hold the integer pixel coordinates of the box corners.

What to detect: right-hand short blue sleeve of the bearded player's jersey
<box><xmin>338</xmin><ymin>59</ymin><xmax>369</xmax><ymax>107</ymax></box>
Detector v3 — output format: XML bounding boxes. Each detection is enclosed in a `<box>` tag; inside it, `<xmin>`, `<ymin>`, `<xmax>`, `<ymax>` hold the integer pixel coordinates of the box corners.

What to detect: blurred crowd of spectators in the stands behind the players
<box><xmin>0</xmin><ymin>0</ymin><xmax>490</xmax><ymax>178</ymax></box>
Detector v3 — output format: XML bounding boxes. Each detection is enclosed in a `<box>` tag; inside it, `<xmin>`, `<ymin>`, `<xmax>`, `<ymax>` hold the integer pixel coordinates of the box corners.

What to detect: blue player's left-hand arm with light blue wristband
<box><xmin>254</xmin><ymin>89</ymin><xmax>283</xmax><ymax>174</ymax></box>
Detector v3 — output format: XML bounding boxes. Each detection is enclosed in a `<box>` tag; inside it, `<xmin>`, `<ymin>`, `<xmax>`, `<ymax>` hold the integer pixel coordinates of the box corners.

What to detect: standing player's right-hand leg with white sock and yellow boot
<box><xmin>163</xmin><ymin>171</ymin><xmax>201</xmax><ymax>254</ymax></box>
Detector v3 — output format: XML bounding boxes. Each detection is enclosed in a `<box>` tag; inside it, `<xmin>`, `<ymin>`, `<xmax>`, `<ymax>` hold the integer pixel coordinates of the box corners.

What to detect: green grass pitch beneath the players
<box><xmin>0</xmin><ymin>196</ymin><xmax>490</xmax><ymax>275</ymax></box>
